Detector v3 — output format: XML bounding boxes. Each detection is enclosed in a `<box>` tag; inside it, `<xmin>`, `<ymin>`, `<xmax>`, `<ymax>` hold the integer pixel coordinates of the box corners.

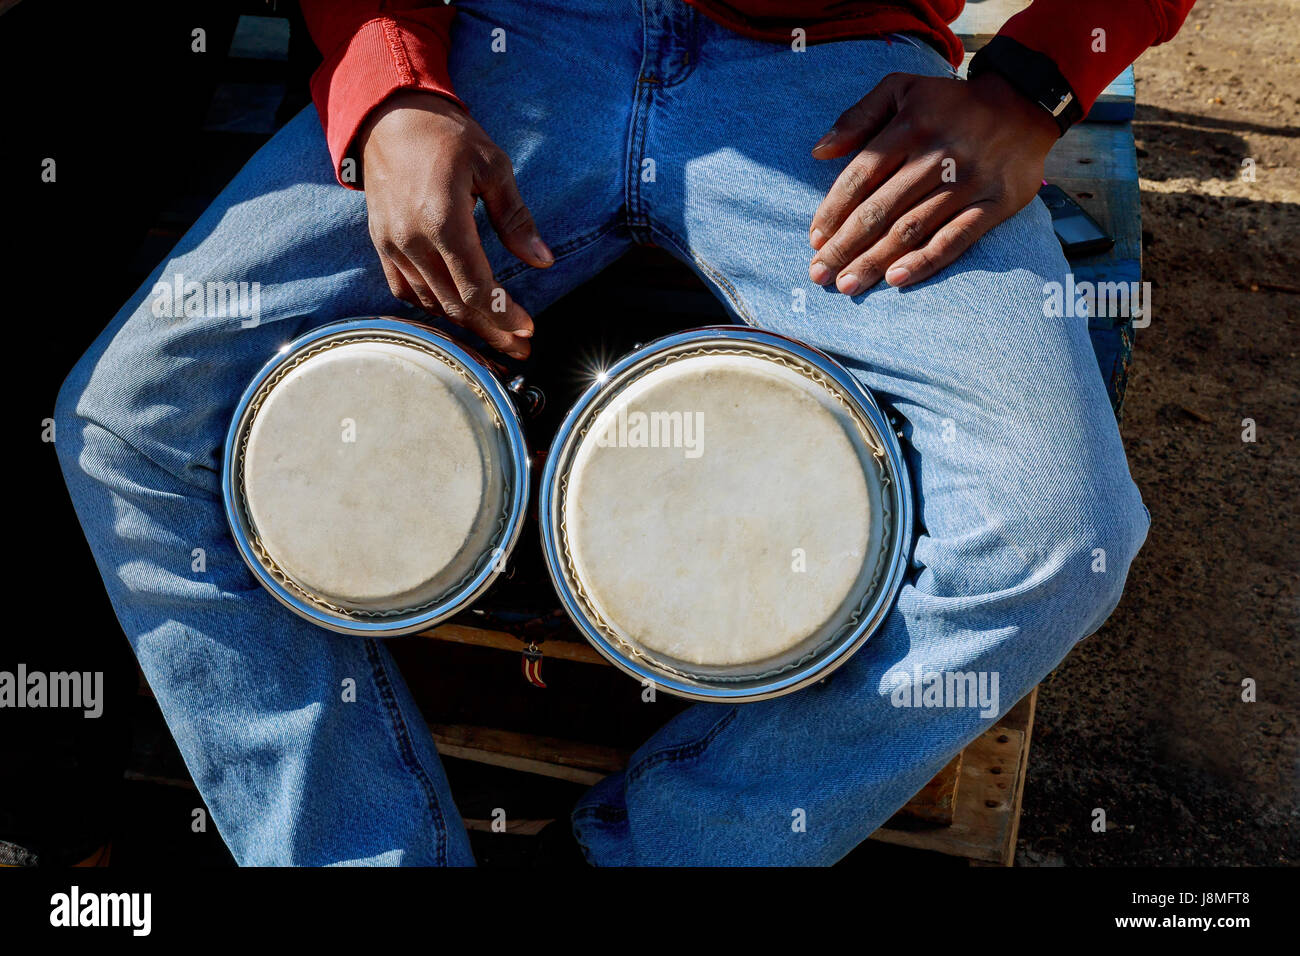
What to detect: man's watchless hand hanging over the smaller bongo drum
<box><xmin>359</xmin><ymin>91</ymin><xmax>555</xmax><ymax>359</ymax></box>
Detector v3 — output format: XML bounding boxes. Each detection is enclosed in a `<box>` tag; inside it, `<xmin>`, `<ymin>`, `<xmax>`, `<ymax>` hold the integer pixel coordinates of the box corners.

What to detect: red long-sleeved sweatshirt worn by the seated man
<box><xmin>302</xmin><ymin>0</ymin><xmax>1193</xmax><ymax>185</ymax></box>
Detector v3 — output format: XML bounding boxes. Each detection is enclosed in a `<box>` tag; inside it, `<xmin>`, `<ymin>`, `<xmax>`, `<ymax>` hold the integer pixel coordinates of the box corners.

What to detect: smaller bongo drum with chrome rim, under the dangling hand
<box><xmin>221</xmin><ymin>319</ymin><xmax>529</xmax><ymax>635</ymax></box>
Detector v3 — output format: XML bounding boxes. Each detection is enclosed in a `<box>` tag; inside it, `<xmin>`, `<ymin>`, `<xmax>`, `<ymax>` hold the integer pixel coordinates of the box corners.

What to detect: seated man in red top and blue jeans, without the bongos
<box><xmin>57</xmin><ymin>0</ymin><xmax>1191</xmax><ymax>865</ymax></box>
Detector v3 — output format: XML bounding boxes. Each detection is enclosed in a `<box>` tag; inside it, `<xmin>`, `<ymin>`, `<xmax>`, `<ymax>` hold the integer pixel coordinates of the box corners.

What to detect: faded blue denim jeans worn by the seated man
<box><xmin>56</xmin><ymin>0</ymin><xmax>1148</xmax><ymax>864</ymax></box>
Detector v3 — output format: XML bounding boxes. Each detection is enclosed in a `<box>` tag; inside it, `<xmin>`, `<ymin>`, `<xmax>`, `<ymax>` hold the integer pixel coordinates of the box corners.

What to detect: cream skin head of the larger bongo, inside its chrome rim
<box><xmin>562</xmin><ymin>349</ymin><xmax>888</xmax><ymax>676</ymax></box>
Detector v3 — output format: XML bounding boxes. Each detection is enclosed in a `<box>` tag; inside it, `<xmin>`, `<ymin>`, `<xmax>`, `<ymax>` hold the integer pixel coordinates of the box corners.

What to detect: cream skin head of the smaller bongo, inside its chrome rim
<box><xmin>239</xmin><ymin>336</ymin><xmax>510</xmax><ymax>615</ymax></box>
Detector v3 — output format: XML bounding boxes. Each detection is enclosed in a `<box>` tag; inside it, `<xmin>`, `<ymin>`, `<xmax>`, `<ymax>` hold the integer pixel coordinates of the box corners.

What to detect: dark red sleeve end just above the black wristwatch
<box><xmin>998</xmin><ymin>0</ymin><xmax>1192</xmax><ymax>113</ymax></box>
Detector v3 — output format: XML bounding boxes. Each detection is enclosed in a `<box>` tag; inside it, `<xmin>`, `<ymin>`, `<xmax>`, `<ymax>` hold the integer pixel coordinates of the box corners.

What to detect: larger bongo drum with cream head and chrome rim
<box><xmin>540</xmin><ymin>326</ymin><xmax>913</xmax><ymax>701</ymax></box>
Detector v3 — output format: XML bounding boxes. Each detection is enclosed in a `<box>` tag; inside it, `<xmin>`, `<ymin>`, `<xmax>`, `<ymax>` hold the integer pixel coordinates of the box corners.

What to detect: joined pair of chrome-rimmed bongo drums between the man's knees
<box><xmin>222</xmin><ymin>317</ymin><xmax>913</xmax><ymax>701</ymax></box>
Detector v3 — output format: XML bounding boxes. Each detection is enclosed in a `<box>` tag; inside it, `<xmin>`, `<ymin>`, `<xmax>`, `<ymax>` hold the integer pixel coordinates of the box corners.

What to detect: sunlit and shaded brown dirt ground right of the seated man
<box><xmin>1018</xmin><ymin>0</ymin><xmax>1300</xmax><ymax>865</ymax></box>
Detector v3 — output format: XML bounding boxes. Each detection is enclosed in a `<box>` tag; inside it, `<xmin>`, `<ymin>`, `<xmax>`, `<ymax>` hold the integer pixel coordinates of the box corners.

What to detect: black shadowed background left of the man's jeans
<box><xmin>0</xmin><ymin>0</ymin><xmax>315</xmax><ymax>864</ymax></box>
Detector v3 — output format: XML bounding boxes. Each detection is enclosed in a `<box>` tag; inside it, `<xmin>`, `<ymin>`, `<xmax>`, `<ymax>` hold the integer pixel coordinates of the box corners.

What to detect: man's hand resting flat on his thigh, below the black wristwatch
<box><xmin>809</xmin><ymin>73</ymin><xmax>1060</xmax><ymax>295</ymax></box>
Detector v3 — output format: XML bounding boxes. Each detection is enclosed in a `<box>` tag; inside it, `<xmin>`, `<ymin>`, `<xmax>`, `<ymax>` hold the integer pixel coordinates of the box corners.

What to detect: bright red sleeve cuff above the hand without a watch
<box><xmin>312</xmin><ymin>17</ymin><xmax>464</xmax><ymax>189</ymax></box>
